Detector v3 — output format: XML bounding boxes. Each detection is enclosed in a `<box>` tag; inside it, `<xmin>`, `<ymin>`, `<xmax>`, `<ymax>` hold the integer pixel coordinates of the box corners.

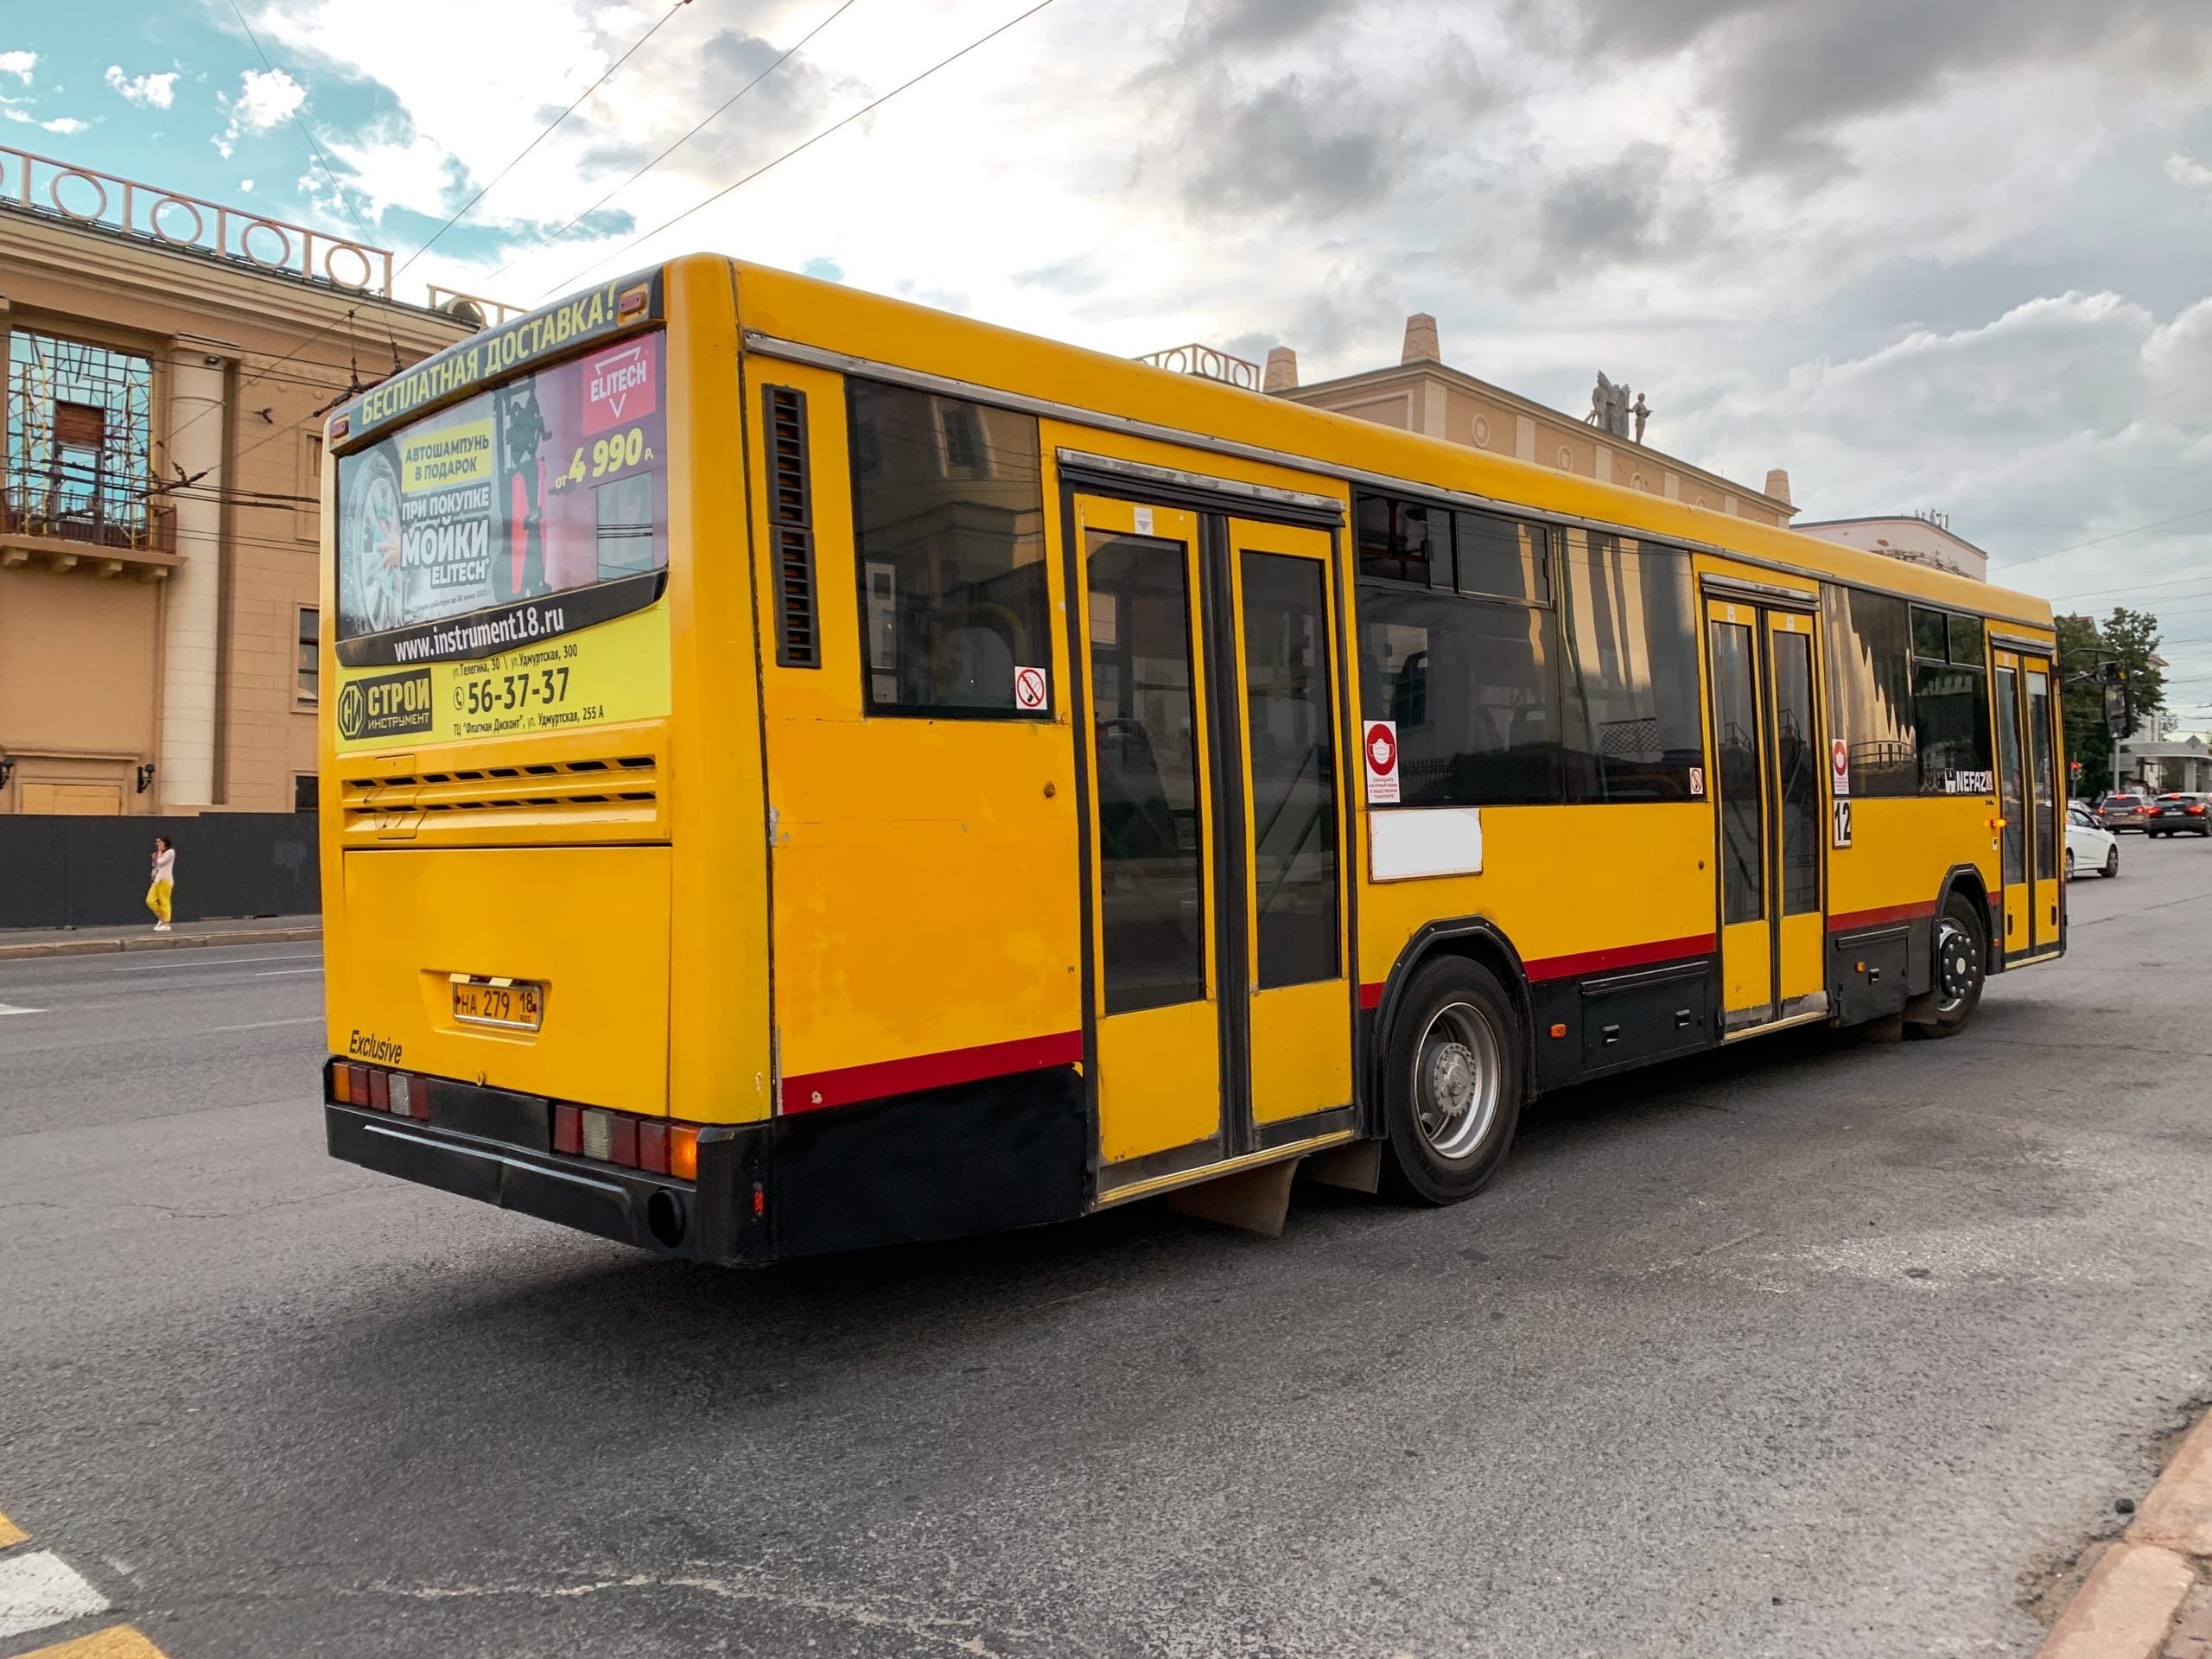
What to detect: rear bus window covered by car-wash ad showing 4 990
<box><xmin>339</xmin><ymin>332</ymin><xmax>668</xmax><ymax>655</ymax></box>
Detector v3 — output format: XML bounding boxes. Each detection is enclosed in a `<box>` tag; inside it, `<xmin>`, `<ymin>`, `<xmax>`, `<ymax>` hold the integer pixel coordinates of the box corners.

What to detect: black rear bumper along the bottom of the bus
<box><xmin>323</xmin><ymin>1103</ymin><xmax>761</xmax><ymax>1261</ymax></box>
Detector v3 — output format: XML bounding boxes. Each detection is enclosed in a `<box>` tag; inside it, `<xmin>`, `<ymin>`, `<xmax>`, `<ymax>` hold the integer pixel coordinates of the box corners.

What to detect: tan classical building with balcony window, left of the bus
<box><xmin>0</xmin><ymin>146</ymin><xmax>480</xmax><ymax>814</ymax></box>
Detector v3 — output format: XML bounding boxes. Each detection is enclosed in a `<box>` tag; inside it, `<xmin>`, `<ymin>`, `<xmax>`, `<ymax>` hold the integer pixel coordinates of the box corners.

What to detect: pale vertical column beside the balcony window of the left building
<box><xmin>155</xmin><ymin>336</ymin><xmax>230</xmax><ymax>807</ymax></box>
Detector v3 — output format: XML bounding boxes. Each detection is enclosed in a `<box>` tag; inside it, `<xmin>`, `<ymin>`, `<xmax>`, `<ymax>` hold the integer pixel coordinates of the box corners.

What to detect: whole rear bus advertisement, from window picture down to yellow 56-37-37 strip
<box><xmin>336</xmin><ymin>332</ymin><xmax>668</xmax><ymax>747</ymax></box>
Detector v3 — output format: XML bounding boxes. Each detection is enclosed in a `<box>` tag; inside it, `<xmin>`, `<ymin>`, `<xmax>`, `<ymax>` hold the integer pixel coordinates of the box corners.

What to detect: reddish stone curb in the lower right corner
<box><xmin>2035</xmin><ymin>1414</ymin><xmax>2212</xmax><ymax>1659</ymax></box>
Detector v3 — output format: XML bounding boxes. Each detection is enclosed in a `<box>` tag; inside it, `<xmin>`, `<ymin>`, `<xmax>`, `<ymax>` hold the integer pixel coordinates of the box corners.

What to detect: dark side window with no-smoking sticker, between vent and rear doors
<box><xmin>847</xmin><ymin>380</ymin><xmax>1051</xmax><ymax>719</ymax></box>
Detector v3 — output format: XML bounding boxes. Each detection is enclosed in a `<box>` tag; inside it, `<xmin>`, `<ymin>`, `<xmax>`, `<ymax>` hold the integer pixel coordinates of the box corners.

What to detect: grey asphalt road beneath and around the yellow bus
<box><xmin>0</xmin><ymin>836</ymin><xmax>2212</xmax><ymax>1659</ymax></box>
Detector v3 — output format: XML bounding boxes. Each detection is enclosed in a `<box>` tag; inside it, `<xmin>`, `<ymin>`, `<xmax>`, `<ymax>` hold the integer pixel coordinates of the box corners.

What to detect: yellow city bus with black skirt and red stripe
<box><xmin>321</xmin><ymin>257</ymin><xmax>2066</xmax><ymax>1263</ymax></box>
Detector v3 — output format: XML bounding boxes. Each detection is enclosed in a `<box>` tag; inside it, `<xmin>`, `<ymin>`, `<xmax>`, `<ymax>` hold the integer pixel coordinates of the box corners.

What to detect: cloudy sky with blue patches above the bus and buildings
<box><xmin>13</xmin><ymin>0</ymin><xmax>2212</xmax><ymax>708</ymax></box>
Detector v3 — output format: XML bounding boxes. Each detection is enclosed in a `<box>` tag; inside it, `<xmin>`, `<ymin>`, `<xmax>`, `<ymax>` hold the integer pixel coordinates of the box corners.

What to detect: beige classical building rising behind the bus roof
<box><xmin>1146</xmin><ymin>312</ymin><xmax>1796</xmax><ymax>524</ymax></box>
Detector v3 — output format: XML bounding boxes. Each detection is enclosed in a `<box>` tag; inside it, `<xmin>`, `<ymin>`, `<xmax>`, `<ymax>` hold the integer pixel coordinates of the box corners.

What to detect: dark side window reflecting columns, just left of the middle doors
<box><xmin>1561</xmin><ymin>529</ymin><xmax>1706</xmax><ymax>801</ymax></box>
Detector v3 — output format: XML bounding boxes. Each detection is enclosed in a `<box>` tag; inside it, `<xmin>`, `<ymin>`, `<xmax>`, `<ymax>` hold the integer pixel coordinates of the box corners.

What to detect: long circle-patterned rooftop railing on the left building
<box><xmin>0</xmin><ymin>143</ymin><xmax>391</xmax><ymax>299</ymax></box>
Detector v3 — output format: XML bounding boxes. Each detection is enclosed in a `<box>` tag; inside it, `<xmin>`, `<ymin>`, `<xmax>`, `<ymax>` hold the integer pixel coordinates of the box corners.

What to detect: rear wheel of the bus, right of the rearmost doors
<box><xmin>1382</xmin><ymin>956</ymin><xmax>1522</xmax><ymax>1204</ymax></box>
